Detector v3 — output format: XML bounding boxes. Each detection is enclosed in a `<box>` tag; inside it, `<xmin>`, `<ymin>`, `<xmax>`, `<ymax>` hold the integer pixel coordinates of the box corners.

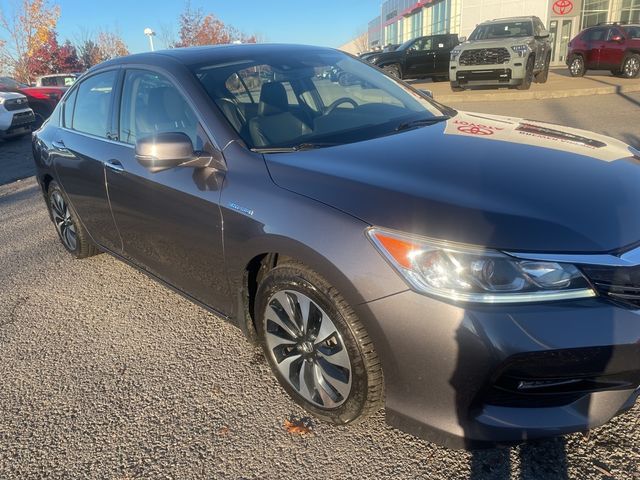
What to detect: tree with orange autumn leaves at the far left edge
<box><xmin>0</xmin><ymin>0</ymin><xmax>60</xmax><ymax>82</ymax></box>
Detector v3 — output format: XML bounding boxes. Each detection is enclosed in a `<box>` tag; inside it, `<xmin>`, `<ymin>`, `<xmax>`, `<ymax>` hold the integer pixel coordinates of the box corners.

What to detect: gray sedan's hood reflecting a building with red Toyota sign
<box><xmin>265</xmin><ymin>112</ymin><xmax>640</xmax><ymax>253</ymax></box>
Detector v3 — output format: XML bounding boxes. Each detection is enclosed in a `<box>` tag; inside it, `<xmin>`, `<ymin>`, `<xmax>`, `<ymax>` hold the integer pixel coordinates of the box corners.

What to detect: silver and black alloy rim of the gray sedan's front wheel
<box><xmin>264</xmin><ymin>290</ymin><xmax>352</xmax><ymax>409</ymax></box>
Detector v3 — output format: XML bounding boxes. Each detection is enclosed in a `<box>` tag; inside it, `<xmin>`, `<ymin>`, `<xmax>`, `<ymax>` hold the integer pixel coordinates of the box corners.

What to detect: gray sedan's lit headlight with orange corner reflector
<box><xmin>367</xmin><ymin>228</ymin><xmax>595</xmax><ymax>303</ymax></box>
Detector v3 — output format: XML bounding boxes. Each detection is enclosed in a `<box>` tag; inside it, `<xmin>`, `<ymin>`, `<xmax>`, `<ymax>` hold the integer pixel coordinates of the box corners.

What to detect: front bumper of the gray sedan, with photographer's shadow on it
<box><xmin>358</xmin><ymin>291</ymin><xmax>640</xmax><ymax>448</ymax></box>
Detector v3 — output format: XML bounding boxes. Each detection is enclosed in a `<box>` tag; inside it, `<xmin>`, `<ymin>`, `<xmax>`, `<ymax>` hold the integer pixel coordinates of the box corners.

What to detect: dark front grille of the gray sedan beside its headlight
<box><xmin>582</xmin><ymin>265</ymin><xmax>640</xmax><ymax>308</ymax></box>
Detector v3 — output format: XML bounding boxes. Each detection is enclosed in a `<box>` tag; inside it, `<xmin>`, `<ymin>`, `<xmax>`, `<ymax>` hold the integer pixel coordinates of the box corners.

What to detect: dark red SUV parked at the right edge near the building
<box><xmin>567</xmin><ymin>23</ymin><xmax>640</xmax><ymax>78</ymax></box>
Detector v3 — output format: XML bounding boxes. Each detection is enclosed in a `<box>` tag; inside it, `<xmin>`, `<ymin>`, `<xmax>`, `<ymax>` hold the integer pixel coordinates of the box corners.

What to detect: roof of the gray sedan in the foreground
<box><xmin>91</xmin><ymin>43</ymin><xmax>338</xmax><ymax>70</ymax></box>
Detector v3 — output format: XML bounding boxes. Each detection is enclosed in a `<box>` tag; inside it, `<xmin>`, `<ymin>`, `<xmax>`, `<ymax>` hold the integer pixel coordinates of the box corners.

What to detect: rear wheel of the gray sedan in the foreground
<box><xmin>47</xmin><ymin>181</ymin><xmax>100</xmax><ymax>258</ymax></box>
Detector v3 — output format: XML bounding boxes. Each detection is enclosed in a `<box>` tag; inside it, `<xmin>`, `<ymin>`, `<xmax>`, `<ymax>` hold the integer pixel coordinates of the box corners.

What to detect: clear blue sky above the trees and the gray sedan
<box><xmin>6</xmin><ymin>0</ymin><xmax>380</xmax><ymax>53</ymax></box>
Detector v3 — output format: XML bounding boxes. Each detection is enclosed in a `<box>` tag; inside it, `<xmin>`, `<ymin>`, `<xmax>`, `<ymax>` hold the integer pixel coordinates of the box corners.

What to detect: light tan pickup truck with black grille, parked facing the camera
<box><xmin>449</xmin><ymin>16</ymin><xmax>551</xmax><ymax>91</ymax></box>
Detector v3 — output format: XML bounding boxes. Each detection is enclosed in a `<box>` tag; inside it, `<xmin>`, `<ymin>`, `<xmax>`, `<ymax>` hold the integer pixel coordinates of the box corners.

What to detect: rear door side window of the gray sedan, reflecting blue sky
<box><xmin>72</xmin><ymin>70</ymin><xmax>117</xmax><ymax>138</ymax></box>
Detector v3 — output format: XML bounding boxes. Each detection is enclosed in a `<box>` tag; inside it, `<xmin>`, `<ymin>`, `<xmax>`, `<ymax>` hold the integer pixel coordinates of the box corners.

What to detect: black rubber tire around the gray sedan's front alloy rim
<box><xmin>255</xmin><ymin>262</ymin><xmax>384</xmax><ymax>425</ymax></box>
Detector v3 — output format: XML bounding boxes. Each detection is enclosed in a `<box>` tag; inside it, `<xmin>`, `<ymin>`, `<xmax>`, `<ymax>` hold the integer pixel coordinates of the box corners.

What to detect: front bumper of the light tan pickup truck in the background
<box><xmin>449</xmin><ymin>59</ymin><xmax>526</xmax><ymax>87</ymax></box>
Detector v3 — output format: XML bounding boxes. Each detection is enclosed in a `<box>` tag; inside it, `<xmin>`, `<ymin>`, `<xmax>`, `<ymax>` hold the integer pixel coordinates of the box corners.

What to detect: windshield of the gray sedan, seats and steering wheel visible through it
<box><xmin>192</xmin><ymin>50</ymin><xmax>452</xmax><ymax>149</ymax></box>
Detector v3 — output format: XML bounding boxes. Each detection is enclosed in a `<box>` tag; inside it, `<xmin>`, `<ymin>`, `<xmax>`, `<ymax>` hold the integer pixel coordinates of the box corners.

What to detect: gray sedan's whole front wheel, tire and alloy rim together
<box><xmin>255</xmin><ymin>263</ymin><xmax>383</xmax><ymax>424</ymax></box>
